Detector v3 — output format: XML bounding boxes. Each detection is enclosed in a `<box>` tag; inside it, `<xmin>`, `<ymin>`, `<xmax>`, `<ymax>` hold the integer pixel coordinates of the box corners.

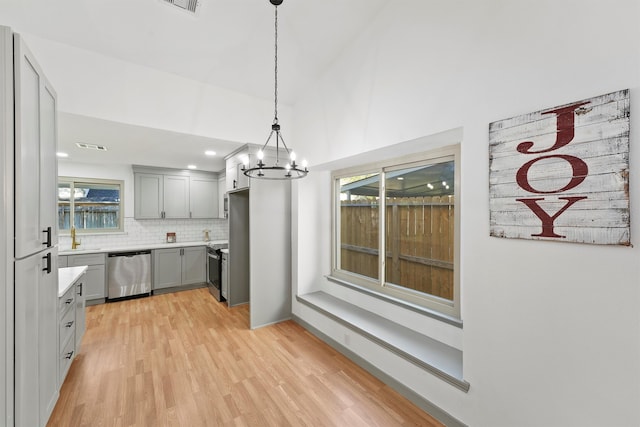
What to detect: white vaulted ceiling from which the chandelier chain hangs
<box><xmin>0</xmin><ymin>0</ymin><xmax>385</xmax><ymax>171</ymax></box>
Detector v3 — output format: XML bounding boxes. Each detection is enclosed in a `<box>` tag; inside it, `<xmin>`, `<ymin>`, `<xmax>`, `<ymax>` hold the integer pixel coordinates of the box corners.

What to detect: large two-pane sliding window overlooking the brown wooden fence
<box><xmin>332</xmin><ymin>146</ymin><xmax>460</xmax><ymax>318</ymax></box>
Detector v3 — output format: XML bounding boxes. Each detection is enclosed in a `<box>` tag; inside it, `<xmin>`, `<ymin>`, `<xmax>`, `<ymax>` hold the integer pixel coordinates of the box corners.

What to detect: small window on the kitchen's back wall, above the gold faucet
<box><xmin>58</xmin><ymin>177</ymin><xmax>124</xmax><ymax>234</ymax></box>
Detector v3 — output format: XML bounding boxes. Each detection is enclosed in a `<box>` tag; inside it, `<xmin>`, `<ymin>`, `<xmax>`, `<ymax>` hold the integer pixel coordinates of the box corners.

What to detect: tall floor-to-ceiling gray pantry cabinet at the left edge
<box><xmin>10</xmin><ymin>27</ymin><xmax>58</xmax><ymax>426</ymax></box>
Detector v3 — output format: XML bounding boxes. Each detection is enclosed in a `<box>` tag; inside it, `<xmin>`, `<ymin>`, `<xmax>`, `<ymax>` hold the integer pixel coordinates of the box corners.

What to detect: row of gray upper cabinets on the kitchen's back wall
<box><xmin>133</xmin><ymin>166</ymin><xmax>218</xmax><ymax>219</ymax></box>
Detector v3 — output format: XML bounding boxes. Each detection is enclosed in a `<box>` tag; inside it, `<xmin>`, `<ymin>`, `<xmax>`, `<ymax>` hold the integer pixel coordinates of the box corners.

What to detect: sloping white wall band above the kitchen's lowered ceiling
<box><xmin>17</xmin><ymin>34</ymin><xmax>291</xmax><ymax>142</ymax></box>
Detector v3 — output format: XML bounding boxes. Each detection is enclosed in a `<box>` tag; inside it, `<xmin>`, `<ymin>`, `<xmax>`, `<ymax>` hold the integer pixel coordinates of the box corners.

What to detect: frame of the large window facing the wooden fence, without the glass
<box><xmin>331</xmin><ymin>144</ymin><xmax>461</xmax><ymax>319</ymax></box>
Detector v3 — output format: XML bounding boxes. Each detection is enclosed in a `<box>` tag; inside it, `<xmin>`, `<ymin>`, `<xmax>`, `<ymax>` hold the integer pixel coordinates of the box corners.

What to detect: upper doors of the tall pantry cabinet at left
<box><xmin>14</xmin><ymin>34</ymin><xmax>57</xmax><ymax>258</ymax></box>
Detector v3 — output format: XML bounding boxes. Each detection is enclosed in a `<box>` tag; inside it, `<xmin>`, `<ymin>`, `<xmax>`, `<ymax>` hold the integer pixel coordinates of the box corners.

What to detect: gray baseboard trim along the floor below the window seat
<box><xmin>292</xmin><ymin>314</ymin><xmax>467</xmax><ymax>427</ymax></box>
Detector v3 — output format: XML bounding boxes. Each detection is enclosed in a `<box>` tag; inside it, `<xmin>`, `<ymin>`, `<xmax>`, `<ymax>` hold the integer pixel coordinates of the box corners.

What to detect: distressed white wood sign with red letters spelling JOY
<box><xmin>489</xmin><ymin>90</ymin><xmax>630</xmax><ymax>245</ymax></box>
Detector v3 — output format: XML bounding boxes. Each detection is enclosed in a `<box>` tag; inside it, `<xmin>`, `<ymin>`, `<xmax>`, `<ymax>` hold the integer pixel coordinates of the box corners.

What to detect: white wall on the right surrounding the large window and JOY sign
<box><xmin>293</xmin><ymin>0</ymin><xmax>640</xmax><ymax>427</ymax></box>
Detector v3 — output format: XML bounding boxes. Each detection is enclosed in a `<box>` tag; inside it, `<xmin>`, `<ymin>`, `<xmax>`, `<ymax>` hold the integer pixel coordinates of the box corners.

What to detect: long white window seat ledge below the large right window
<box><xmin>297</xmin><ymin>292</ymin><xmax>470</xmax><ymax>392</ymax></box>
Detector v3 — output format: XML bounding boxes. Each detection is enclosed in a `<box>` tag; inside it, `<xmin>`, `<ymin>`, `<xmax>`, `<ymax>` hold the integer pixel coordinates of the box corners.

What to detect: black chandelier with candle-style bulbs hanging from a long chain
<box><xmin>242</xmin><ymin>0</ymin><xmax>309</xmax><ymax>179</ymax></box>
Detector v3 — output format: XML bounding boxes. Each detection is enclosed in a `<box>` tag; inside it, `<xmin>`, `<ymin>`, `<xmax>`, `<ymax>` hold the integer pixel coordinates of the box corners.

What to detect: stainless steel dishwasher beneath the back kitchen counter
<box><xmin>107</xmin><ymin>251</ymin><xmax>151</xmax><ymax>299</ymax></box>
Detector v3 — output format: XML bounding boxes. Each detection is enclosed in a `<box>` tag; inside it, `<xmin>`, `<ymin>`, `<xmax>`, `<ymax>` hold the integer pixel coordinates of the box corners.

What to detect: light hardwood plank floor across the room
<box><xmin>48</xmin><ymin>289</ymin><xmax>441</xmax><ymax>427</ymax></box>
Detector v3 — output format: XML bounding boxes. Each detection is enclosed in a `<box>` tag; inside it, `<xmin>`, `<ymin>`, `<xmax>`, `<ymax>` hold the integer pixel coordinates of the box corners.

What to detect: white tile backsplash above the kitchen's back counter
<box><xmin>59</xmin><ymin>218</ymin><xmax>229</xmax><ymax>250</ymax></box>
